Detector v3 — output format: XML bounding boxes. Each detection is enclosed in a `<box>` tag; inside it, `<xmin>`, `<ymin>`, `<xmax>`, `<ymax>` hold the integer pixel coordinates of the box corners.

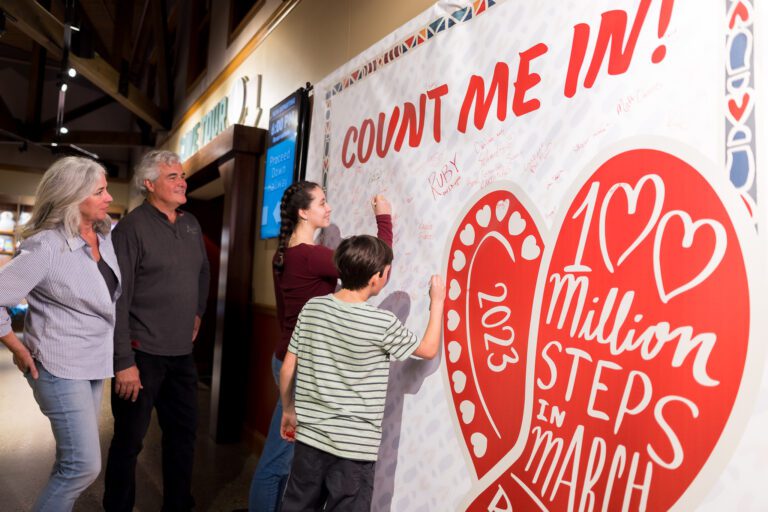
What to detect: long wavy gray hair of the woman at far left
<box><xmin>20</xmin><ymin>156</ymin><xmax>112</xmax><ymax>238</ymax></box>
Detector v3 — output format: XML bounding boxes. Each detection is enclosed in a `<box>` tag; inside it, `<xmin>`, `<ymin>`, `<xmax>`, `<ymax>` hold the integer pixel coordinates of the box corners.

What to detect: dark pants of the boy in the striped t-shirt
<box><xmin>280</xmin><ymin>442</ymin><xmax>376</xmax><ymax>512</ymax></box>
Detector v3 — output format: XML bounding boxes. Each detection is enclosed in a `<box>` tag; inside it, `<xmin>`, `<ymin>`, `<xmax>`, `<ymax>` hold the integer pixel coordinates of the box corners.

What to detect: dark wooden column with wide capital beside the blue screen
<box><xmin>184</xmin><ymin>125</ymin><xmax>266</xmax><ymax>442</ymax></box>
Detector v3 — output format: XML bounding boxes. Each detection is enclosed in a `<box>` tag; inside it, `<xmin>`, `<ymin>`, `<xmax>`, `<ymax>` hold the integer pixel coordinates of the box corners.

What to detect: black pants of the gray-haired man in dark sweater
<box><xmin>104</xmin><ymin>352</ymin><xmax>197</xmax><ymax>512</ymax></box>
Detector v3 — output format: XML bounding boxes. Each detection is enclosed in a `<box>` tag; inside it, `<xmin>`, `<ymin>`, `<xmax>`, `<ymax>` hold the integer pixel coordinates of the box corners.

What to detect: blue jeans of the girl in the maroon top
<box><xmin>248</xmin><ymin>356</ymin><xmax>293</xmax><ymax>512</ymax></box>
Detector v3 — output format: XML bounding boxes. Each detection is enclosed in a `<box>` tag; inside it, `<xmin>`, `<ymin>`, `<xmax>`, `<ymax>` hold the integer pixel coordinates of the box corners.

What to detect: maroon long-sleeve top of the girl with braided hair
<box><xmin>273</xmin><ymin>215</ymin><xmax>392</xmax><ymax>361</ymax></box>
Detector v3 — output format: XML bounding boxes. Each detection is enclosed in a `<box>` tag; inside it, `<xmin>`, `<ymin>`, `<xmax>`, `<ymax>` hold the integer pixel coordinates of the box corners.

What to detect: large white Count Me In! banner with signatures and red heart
<box><xmin>308</xmin><ymin>0</ymin><xmax>768</xmax><ymax>511</ymax></box>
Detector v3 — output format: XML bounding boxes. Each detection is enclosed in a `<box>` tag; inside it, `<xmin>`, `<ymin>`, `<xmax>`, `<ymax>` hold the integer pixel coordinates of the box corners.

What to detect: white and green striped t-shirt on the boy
<box><xmin>288</xmin><ymin>294</ymin><xmax>419</xmax><ymax>461</ymax></box>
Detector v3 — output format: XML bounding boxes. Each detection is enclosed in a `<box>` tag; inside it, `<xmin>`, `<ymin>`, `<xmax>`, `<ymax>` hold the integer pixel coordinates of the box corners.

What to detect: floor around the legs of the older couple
<box><xmin>0</xmin><ymin>344</ymin><xmax>257</xmax><ymax>512</ymax></box>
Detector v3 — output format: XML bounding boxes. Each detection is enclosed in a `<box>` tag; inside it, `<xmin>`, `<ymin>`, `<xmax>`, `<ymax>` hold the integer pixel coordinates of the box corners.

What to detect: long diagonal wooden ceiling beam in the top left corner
<box><xmin>0</xmin><ymin>0</ymin><xmax>168</xmax><ymax>129</ymax></box>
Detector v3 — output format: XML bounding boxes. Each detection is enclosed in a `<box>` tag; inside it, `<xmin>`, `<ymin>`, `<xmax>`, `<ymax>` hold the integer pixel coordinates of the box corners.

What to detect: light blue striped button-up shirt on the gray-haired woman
<box><xmin>0</xmin><ymin>229</ymin><xmax>121</xmax><ymax>380</ymax></box>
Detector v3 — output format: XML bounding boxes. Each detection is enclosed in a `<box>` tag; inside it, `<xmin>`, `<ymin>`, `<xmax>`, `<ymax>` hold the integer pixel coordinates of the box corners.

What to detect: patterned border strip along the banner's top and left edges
<box><xmin>322</xmin><ymin>0</ymin><xmax>499</xmax><ymax>188</ymax></box>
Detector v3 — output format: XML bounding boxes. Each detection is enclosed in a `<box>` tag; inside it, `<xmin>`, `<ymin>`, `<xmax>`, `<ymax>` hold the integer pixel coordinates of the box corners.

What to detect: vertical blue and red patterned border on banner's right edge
<box><xmin>725</xmin><ymin>0</ymin><xmax>757</xmax><ymax>223</ymax></box>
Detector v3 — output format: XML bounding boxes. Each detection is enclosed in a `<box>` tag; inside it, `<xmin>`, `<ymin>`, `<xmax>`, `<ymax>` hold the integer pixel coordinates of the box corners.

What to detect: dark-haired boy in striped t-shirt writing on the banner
<box><xmin>280</xmin><ymin>235</ymin><xmax>445</xmax><ymax>512</ymax></box>
